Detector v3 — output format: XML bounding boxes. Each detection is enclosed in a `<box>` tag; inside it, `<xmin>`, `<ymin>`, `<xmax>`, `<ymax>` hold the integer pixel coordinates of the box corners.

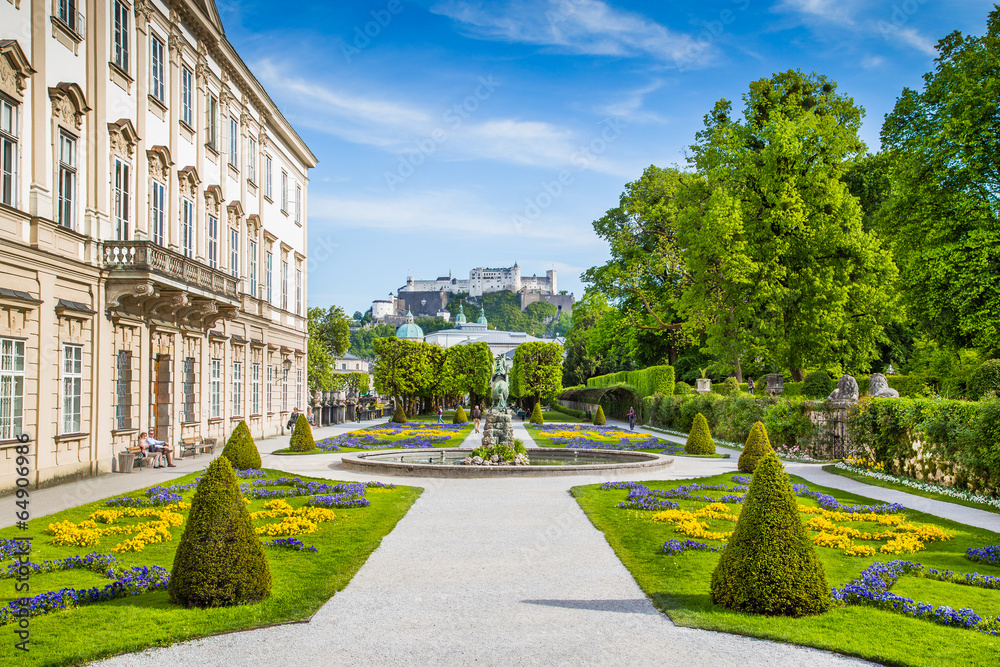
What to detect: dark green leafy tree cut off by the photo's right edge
<box><xmin>879</xmin><ymin>8</ymin><xmax>1000</xmax><ymax>350</ymax></box>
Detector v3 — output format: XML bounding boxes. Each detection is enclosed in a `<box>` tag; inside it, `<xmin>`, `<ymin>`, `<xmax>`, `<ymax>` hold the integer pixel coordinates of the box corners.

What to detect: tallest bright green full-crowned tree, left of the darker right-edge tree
<box><xmin>677</xmin><ymin>71</ymin><xmax>895</xmax><ymax>379</ymax></box>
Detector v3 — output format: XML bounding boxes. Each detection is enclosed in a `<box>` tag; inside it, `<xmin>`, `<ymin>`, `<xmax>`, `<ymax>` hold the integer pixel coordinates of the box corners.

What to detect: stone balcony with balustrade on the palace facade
<box><xmin>103</xmin><ymin>241</ymin><xmax>242</xmax><ymax>331</ymax></box>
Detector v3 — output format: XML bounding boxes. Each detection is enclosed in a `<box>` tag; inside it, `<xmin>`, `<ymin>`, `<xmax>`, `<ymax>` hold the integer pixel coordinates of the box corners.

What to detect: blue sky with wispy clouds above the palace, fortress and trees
<box><xmin>218</xmin><ymin>0</ymin><xmax>993</xmax><ymax>314</ymax></box>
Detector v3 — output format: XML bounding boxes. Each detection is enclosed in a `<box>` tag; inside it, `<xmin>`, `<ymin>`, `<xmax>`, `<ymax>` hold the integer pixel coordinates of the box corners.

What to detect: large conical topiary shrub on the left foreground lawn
<box><xmin>168</xmin><ymin>456</ymin><xmax>271</xmax><ymax>608</ymax></box>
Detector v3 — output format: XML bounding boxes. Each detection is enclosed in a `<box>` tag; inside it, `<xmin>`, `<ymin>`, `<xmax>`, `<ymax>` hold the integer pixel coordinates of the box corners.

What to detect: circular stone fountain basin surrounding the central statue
<box><xmin>341</xmin><ymin>448</ymin><xmax>674</xmax><ymax>478</ymax></box>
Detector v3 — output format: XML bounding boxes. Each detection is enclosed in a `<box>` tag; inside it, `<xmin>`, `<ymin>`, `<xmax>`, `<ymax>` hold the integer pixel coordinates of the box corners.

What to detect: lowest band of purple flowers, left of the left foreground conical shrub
<box><xmin>0</xmin><ymin>565</ymin><xmax>170</xmax><ymax>625</ymax></box>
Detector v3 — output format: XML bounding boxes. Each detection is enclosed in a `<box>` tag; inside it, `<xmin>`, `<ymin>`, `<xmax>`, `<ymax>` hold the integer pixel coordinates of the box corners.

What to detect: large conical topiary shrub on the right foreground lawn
<box><xmin>712</xmin><ymin>451</ymin><xmax>830</xmax><ymax>616</ymax></box>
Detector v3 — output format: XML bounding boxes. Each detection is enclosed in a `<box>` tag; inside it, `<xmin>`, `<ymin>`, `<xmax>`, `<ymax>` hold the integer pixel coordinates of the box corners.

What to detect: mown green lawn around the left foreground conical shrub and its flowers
<box><xmin>0</xmin><ymin>471</ymin><xmax>422</xmax><ymax>667</ymax></box>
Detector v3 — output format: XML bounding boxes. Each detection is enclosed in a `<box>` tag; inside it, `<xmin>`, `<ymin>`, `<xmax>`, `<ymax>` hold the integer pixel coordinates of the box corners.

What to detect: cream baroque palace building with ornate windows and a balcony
<box><xmin>0</xmin><ymin>0</ymin><xmax>316</xmax><ymax>492</ymax></box>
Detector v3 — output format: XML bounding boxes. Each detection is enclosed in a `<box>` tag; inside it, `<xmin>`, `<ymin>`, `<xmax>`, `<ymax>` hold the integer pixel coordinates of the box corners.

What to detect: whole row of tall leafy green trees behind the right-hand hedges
<box><xmin>566</xmin><ymin>9</ymin><xmax>1000</xmax><ymax>384</ymax></box>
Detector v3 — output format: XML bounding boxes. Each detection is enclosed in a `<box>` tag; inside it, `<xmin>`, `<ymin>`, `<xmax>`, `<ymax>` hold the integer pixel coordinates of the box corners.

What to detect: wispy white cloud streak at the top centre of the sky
<box><xmin>431</xmin><ymin>0</ymin><xmax>712</xmax><ymax>65</ymax></box>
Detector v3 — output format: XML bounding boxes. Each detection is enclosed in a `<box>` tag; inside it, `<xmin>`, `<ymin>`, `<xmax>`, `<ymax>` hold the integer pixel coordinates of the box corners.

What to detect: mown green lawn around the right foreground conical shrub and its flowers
<box><xmin>572</xmin><ymin>474</ymin><xmax>1000</xmax><ymax>667</ymax></box>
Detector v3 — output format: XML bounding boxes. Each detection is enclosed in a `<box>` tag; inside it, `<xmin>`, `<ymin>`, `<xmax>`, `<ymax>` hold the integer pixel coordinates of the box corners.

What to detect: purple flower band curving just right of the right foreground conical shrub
<box><xmin>831</xmin><ymin>560</ymin><xmax>1000</xmax><ymax>635</ymax></box>
